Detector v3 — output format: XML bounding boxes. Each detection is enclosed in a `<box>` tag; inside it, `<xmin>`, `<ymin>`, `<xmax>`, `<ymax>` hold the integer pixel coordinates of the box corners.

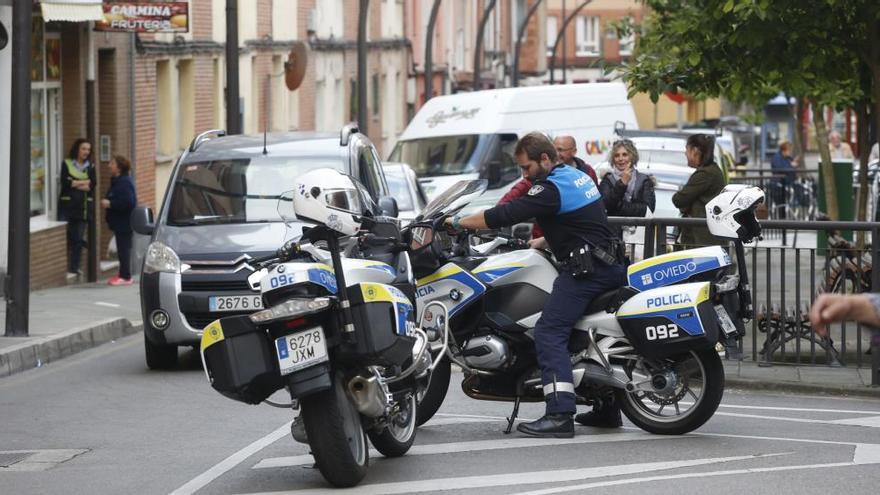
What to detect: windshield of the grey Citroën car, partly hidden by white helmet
<box><xmin>167</xmin><ymin>156</ymin><xmax>344</xmax><ymax>226</ymax></box>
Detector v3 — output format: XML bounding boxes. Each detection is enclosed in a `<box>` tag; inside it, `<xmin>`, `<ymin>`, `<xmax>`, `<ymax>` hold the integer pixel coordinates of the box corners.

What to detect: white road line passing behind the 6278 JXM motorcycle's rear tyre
<box><xmin>253</xmin><ymin>432</ymin><xmax>676</xmax><ymax>469</ymax></box>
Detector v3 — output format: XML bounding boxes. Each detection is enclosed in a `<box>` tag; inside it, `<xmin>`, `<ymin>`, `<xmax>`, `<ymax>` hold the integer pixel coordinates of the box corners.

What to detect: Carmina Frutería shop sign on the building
<box><xmin>95</xmin><ymin>2</ymin><xmax>189</xmax><ymax>33</ymax></box>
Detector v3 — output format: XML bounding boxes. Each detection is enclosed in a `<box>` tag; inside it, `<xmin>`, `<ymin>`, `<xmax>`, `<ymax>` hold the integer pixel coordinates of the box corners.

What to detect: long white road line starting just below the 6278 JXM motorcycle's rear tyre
<box><xmin>251</xmin><ymin>454</ymin><xmax>785</xmax><ymax>495</ymax></box>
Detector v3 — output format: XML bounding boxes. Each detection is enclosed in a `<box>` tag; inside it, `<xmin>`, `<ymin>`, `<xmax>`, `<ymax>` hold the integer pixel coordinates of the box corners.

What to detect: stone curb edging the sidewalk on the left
<box><xmin>0</xmin><ymin>318</ymin><xmax>143</xmax><ymax>378</ymax></box>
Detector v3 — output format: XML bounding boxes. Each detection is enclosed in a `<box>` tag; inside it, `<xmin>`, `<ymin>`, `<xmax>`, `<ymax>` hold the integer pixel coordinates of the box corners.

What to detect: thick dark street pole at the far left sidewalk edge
<box><xmin>0</xmin><ymin>0</ymin><xmax>34</xmax><ymax>337</ymax></box>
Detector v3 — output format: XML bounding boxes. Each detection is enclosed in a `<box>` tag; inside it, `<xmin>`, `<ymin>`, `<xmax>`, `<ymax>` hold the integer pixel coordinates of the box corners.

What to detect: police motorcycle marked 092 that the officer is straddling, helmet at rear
<box><xmin>408</xmin><ymin>181</ymin><xmax>764</xmax><ymax>435</ymax></box>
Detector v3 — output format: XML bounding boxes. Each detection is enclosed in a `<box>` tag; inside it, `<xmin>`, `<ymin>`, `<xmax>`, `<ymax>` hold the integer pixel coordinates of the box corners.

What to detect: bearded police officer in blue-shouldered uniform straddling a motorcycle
<box><xmin>447</xmin><ymin>132</ymin><xmax>626</xmax><ymax>438</ymax></box>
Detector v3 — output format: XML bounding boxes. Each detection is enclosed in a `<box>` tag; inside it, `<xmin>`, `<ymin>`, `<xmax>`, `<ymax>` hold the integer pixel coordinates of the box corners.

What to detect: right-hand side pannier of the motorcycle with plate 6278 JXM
<box><xmin>340</xmin><ymin>282</ymin><xmax>415</xmax><ymax>366</ymax></box>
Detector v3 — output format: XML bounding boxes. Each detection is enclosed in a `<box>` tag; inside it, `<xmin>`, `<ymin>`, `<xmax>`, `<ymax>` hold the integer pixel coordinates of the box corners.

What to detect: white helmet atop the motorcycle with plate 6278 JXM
<box><xmin>293</xmin><ymin>168</ymin><xmax>365</xmax><ymax>235</ymax></box>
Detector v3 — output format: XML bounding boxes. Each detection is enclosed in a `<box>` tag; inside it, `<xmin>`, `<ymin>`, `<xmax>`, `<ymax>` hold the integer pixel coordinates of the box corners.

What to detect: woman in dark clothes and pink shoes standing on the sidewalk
<box><xmin>101</xmin><ymin>155</ymin><xmax>137</xmax><ymax>285</ymax></box>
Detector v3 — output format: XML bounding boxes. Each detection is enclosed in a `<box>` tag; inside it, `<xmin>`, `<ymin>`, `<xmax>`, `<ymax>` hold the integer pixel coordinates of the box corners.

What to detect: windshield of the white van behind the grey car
<box><xmin>388</xmin><ymin>134</ymin><xmax>495</xmax><ymax>177</ymax></box>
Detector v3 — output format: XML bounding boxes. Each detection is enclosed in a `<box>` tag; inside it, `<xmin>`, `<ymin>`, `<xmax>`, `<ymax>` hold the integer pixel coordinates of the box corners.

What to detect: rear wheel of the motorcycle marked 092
<box><xmin>615</xmin><ymin>348</ymin><xmax>724</xmax><ymax>435</ymax></box>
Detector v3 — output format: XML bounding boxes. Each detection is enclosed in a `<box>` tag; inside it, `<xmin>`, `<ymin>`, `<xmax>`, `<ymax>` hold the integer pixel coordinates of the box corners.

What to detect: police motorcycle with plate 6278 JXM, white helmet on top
<box><xmin>200</xmin><ymin>169</ymin><xmax>444</xmax><ymax>487</ymax></box>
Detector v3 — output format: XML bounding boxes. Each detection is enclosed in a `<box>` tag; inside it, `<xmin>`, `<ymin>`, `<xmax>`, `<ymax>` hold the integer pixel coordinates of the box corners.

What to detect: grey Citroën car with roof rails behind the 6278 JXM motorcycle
<box><xmin>132</xmin><ymin>125</ymin><xmax>397</xmax><ymax>369</ymax></box>
